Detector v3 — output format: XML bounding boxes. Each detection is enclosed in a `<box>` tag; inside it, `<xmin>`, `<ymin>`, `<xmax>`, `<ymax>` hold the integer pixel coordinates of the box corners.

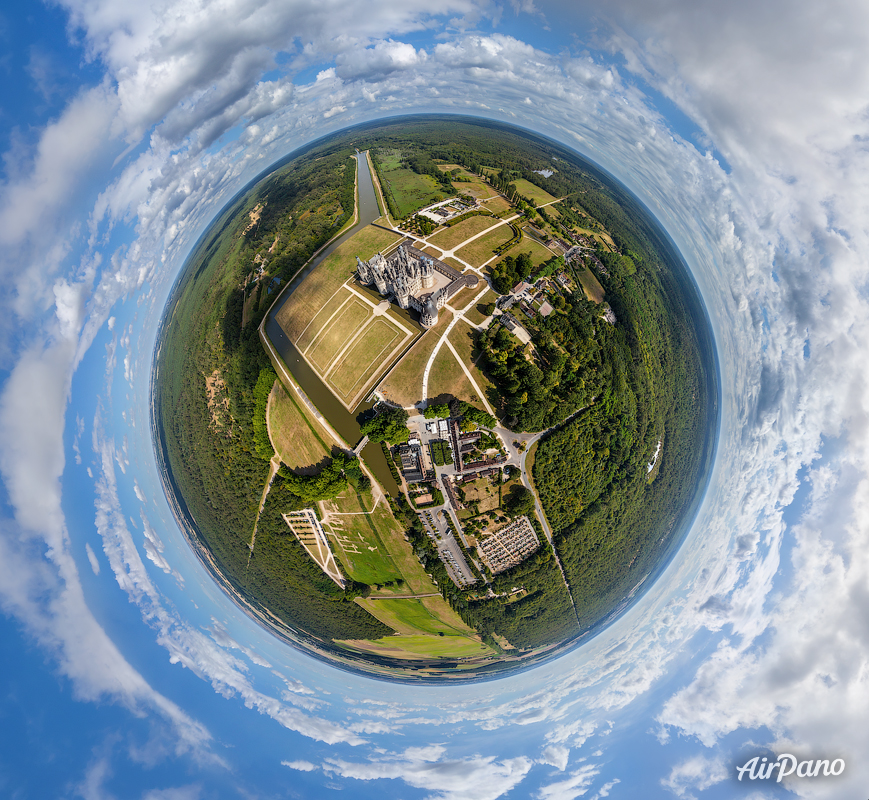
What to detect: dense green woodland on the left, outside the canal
<box><xmin>155</xmin><ymin>134</ymin><xmax>392</xmax><ymax>640</ymax></box>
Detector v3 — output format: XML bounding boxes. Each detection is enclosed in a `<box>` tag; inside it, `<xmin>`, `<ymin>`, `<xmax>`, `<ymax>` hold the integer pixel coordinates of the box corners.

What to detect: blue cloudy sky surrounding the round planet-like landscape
<box><xmin>0</xmin><ymin>0</ymin><xmax>869</xmax><ymax>800</ymax></box>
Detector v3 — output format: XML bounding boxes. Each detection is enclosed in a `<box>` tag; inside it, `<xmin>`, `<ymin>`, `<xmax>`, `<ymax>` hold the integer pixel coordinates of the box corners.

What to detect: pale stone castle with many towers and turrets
<box><xmin>356</xmin><ymin>239</ymin><xmax>479</xmax><ymax>328</ymax></box>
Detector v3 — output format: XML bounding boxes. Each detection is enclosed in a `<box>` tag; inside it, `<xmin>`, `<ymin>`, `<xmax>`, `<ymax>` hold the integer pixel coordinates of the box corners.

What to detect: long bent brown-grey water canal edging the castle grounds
<box><xmin>264</xmin><ymin>153</ymin><xmax>399</xmax><ymax>497</ymax></box>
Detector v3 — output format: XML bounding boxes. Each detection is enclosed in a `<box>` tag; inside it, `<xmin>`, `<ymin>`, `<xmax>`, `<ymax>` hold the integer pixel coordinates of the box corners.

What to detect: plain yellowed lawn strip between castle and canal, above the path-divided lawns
<box><xmin>277</xmin><ymin>225</ymin><xmax>402</xmax><ymax>346</ymax></box>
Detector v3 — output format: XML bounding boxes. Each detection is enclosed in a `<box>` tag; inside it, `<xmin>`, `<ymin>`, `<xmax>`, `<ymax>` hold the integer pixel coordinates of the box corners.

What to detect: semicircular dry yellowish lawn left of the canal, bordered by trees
<box><xmin>268</xmin><ymin>381</ymin><xmax>332</xmax><ymax>474</ymax></box>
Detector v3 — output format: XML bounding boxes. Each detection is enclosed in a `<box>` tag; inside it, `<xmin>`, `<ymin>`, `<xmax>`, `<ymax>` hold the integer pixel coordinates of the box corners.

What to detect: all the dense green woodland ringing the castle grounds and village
<box><xmin>156</xmin><ymin>115</ymin><xmax>714</xmax><ymax>664</ymax></box>
